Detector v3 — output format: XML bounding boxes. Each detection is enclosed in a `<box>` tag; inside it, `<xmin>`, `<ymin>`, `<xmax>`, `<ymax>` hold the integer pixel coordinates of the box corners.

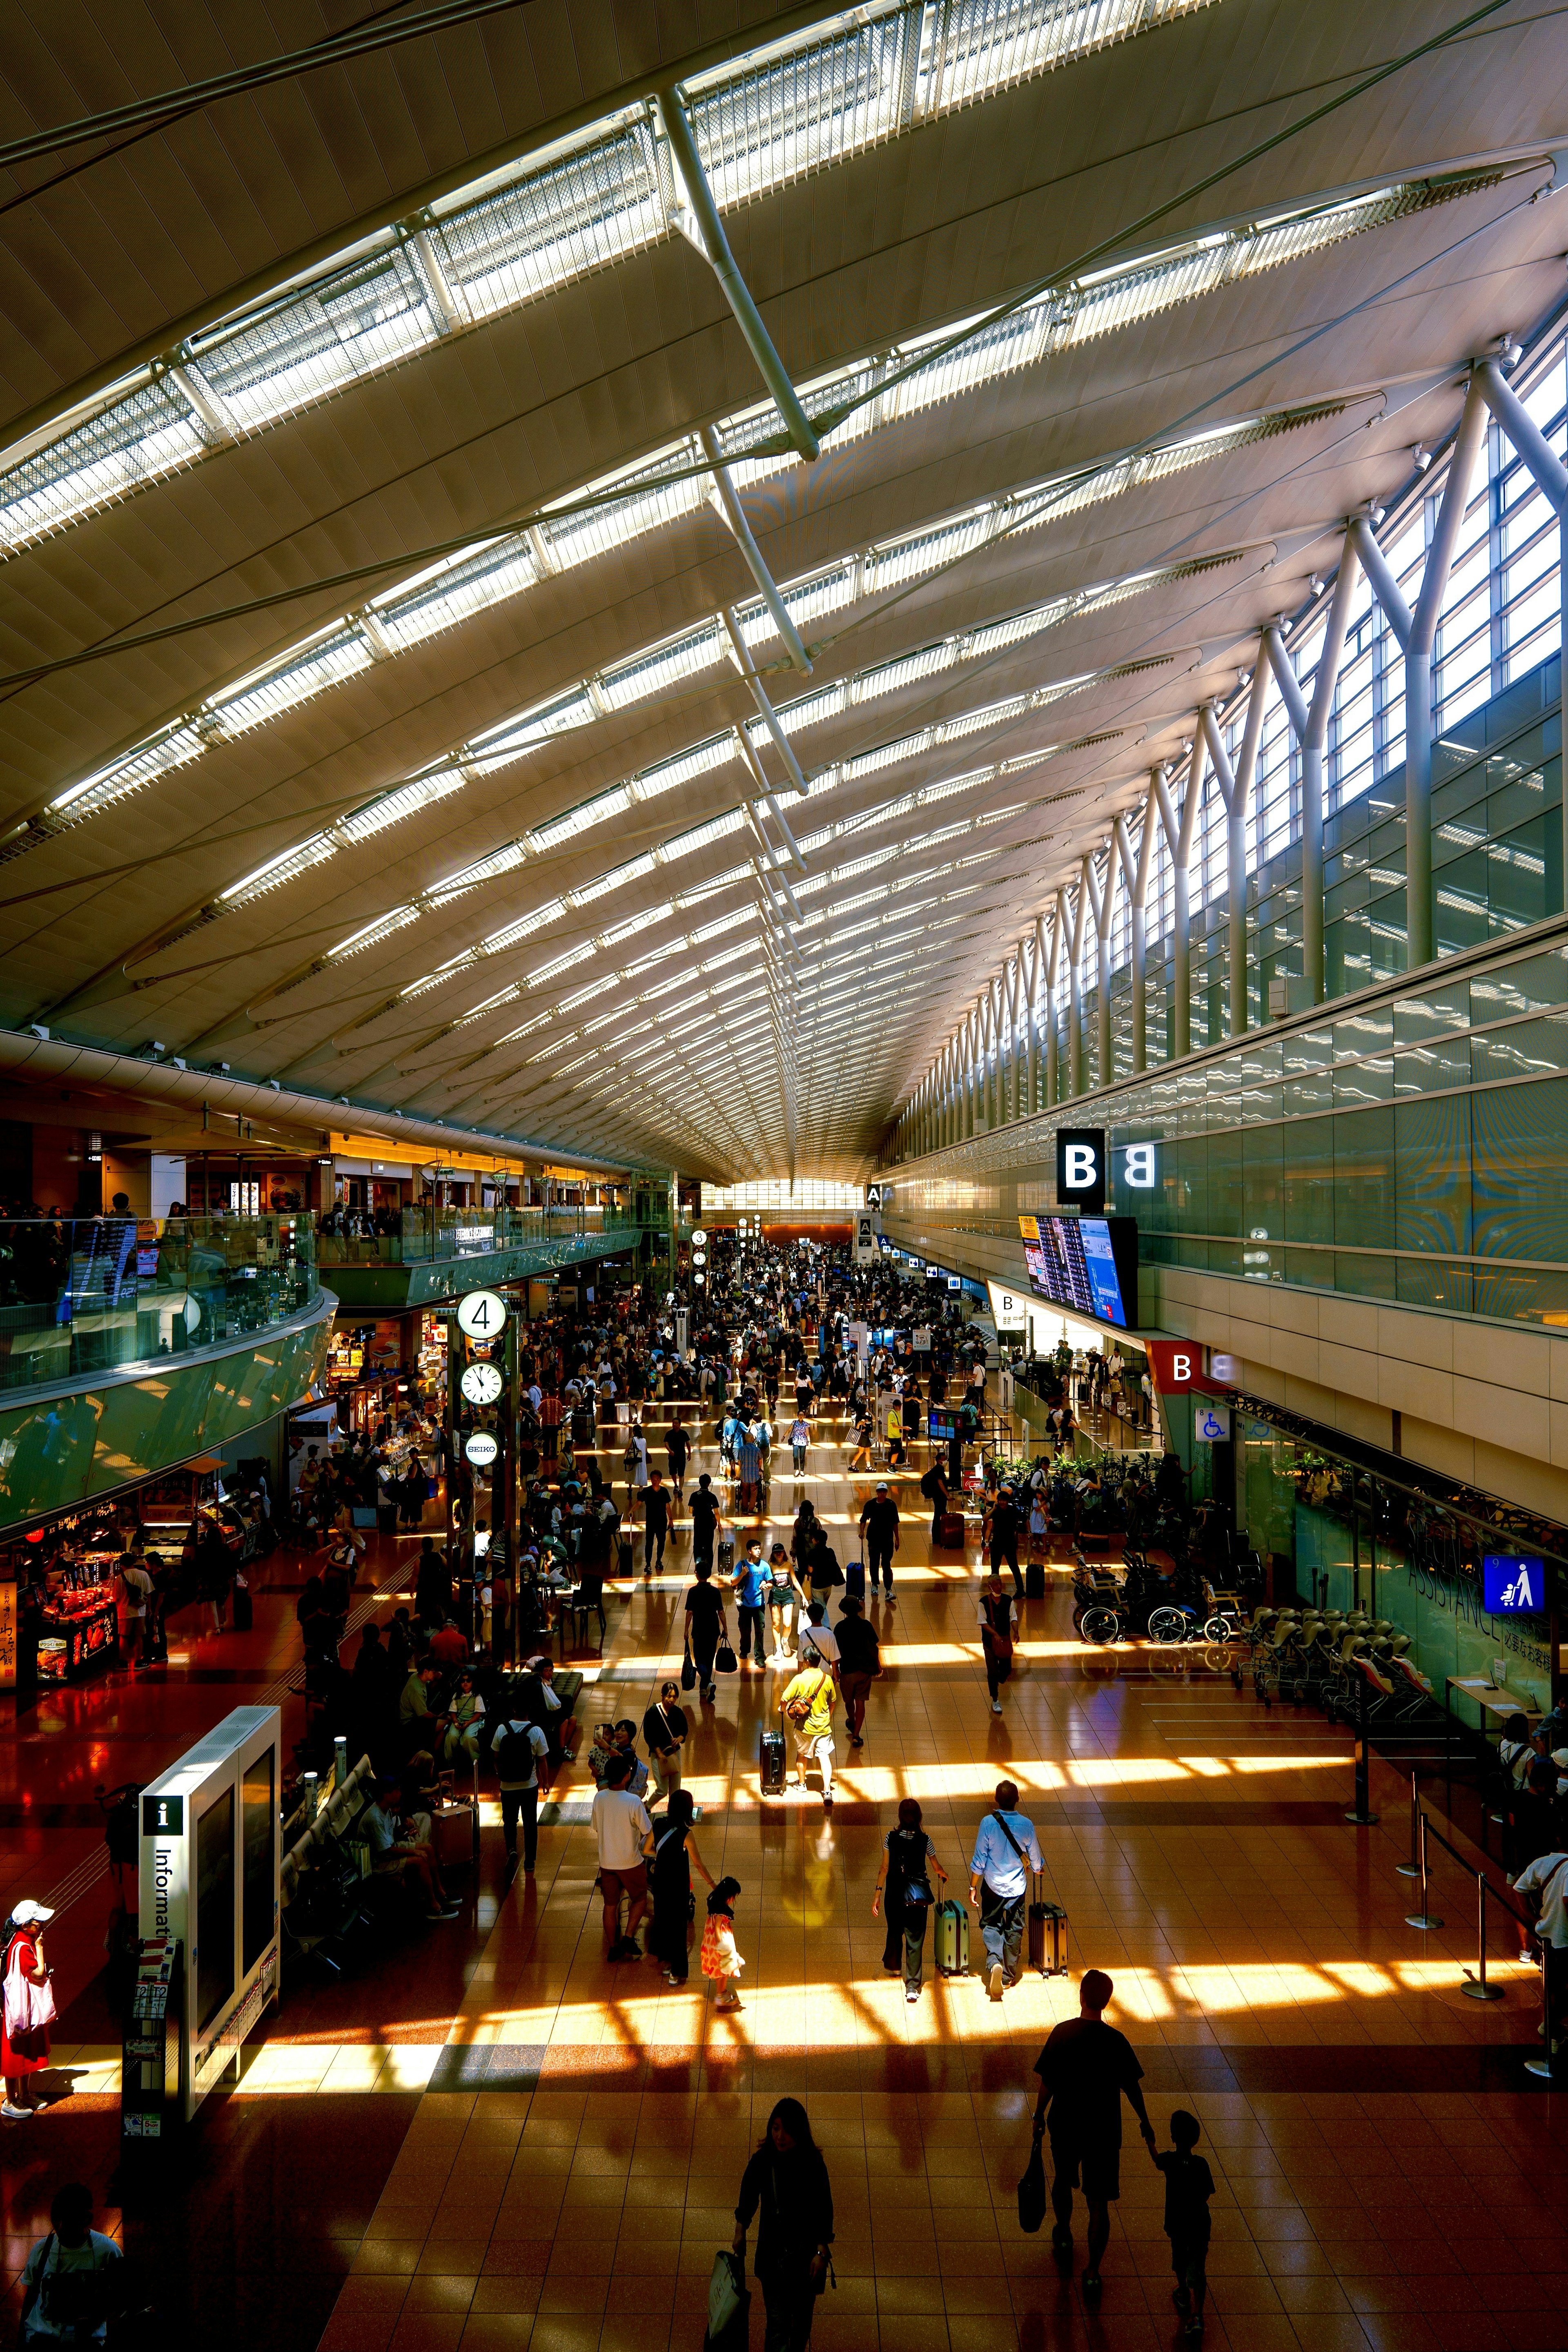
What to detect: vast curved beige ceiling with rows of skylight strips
<box><xmin>0</xmin><ymin>0</ymin><xmax>1568</xmax><ymax>1176</ymax></box>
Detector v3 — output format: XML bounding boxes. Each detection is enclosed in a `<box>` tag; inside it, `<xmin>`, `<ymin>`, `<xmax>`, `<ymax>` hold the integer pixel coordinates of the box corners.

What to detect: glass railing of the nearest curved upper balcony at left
<box><xmin>0</xmin><ymin>1216</ymin><xmax>317</xmax><ymax>1390</ymax></box>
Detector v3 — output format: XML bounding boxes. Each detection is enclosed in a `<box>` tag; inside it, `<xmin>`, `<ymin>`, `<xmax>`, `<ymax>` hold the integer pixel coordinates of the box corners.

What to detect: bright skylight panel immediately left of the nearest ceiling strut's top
<box><xmin>430</xmin><ymin>118</ymin><xmax>668</xmax><ymax>318</ymax></box>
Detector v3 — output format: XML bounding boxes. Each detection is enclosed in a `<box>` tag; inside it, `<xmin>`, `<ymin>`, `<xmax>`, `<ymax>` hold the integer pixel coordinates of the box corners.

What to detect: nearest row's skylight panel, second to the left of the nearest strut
<box><xmin>190</xmin><ymin>249</ymin><xmax>442</xmax><ymax>430</ymax></box>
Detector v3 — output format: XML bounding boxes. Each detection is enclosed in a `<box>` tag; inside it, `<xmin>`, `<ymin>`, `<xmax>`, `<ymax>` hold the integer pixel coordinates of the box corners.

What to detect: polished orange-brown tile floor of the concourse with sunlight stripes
<box><xmin>0</xmin><ymin>1401</ymin><xmax>1568</xmax><ymax>2352</ymax></box>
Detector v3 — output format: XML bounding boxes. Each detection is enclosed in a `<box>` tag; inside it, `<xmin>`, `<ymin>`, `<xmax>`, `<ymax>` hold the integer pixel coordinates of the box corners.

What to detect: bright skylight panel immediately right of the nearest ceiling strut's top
<box><xmin>691</xmin><ymin>9</ymin><xmax>922</xmax><ymax>207</ymax></box>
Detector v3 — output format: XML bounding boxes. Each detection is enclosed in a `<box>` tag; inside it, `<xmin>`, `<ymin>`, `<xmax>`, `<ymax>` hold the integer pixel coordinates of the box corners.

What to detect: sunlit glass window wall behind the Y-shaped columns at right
<box><xmin>1056</xmin><ymin>348</ymin><xmax>1568</xmax><ymax>1087</ymax></box>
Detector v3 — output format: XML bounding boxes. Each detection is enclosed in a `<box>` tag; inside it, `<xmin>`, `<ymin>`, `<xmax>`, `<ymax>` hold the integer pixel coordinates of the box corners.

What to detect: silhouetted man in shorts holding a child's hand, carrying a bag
<box><xmin>1034</xmin><ymin>1966</ymin><xmax>1154</xmax><ymax>2296</ymax></box>
